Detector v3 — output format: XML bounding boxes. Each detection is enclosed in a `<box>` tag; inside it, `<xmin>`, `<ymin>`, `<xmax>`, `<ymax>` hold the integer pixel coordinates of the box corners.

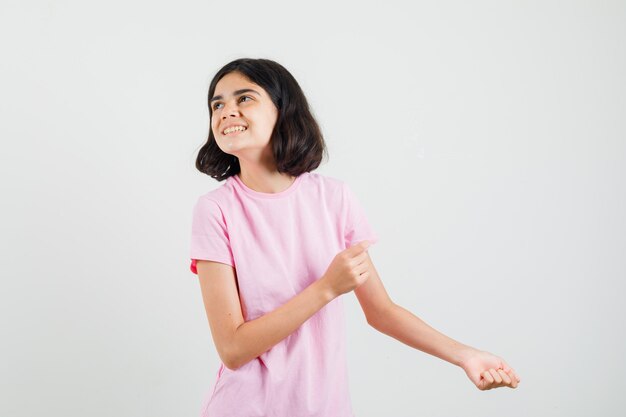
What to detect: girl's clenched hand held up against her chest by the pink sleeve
<box><xmin>321</xmin><ymin>240</ymin><xmax>370</xmax><ymax>297</ymax></box>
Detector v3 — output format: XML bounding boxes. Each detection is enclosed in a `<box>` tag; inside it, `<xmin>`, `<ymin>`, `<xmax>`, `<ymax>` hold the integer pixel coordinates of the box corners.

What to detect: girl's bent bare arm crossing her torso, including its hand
<box><xmin>196</xmin><ymin>239</ymin><xmax>369</xmax><ymax>370</ymax></box>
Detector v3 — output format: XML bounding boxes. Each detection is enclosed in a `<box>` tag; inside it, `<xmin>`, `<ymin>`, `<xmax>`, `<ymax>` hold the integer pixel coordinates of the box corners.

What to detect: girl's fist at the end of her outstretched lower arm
<box><xmin>461</xmin><ymin>349</ymin><xmax>521</xmax><ymax>391</ymax></box>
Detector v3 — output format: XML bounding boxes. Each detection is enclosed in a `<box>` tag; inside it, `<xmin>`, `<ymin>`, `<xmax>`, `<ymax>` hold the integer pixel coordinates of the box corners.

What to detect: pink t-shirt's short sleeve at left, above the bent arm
<box><xmin>190</xmin><ymin>197</ymin><xmax>235</xmax><ymax>275</ymax></box>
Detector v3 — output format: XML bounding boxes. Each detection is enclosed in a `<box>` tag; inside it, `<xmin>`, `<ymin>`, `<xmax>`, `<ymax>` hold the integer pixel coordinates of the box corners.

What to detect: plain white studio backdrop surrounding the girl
<box><xmin>0</xmin><ymin>0</ymin><xmax>626</xmax><ymax>417</ymax></box>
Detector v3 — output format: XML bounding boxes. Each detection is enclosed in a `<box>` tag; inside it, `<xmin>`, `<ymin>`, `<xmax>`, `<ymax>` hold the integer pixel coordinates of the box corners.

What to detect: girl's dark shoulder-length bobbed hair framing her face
<box><xmin>196</xmin><ymin>58</ymin><xmax>328</xmax><ymax>181</ymax></box>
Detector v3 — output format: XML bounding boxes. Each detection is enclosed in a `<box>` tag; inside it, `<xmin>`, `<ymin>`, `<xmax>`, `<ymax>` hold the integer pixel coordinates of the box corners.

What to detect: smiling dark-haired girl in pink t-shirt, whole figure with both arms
<box><xmin>191</xmin><ymin>59</ymin><xmax>520</xmax><ymax>417</ymax></box>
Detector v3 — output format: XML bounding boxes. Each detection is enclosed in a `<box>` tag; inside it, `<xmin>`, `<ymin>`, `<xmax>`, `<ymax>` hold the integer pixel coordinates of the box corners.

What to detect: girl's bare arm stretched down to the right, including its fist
<box><xmin>354</xmin><ymin>254</ymin><xmax>520</xmax><ymax>390</ymax></box>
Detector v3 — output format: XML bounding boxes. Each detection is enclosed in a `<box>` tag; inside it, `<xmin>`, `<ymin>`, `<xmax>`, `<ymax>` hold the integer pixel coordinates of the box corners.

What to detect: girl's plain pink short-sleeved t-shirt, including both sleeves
<box><xmin>191</xmin><ymin>172</ymin><xmax>378</xmax><ymax>417</ymax></box>
